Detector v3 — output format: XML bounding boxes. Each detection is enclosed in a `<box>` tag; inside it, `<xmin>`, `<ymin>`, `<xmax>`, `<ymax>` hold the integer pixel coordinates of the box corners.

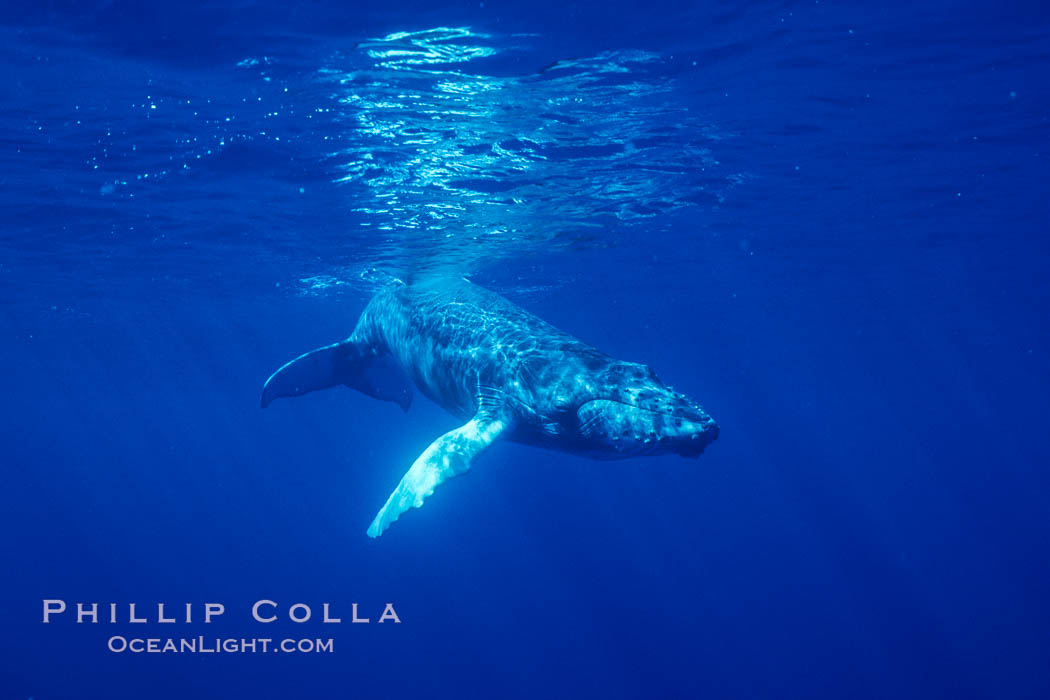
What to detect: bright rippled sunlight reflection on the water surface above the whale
<box><xmin>320</xmin><ymin>27</ymin><xmax>732</xmax><ymax>285</ymax></box>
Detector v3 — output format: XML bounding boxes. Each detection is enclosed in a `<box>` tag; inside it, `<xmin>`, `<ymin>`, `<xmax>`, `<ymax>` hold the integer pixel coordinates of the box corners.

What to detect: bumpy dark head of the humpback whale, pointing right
<box><xmin>575</xmin><ymin>362</ymin><xmax>718</xmax><ymax>459</ymax></box>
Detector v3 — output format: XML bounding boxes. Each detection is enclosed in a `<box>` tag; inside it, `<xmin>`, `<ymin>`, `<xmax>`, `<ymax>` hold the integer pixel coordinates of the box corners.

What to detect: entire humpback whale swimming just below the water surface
<box><xmin>261</xmin><ymin>279</ymin><xmax>718</xmax><ymax>537</ymax></box>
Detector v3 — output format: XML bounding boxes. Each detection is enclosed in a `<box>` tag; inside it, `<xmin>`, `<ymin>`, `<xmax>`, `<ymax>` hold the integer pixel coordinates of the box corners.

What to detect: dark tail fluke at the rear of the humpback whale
<box><xmin>261</xmin><ymin>340</ymin><xmax>412</xmax><ymax>410</ymax></box>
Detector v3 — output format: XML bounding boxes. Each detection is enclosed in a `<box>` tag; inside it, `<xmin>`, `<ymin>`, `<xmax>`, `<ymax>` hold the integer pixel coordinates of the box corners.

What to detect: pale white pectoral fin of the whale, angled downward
<box><xmin>369</xmin><ymin>416</ymin><xmax>507</xmax><ymax>537</ymax></box>
